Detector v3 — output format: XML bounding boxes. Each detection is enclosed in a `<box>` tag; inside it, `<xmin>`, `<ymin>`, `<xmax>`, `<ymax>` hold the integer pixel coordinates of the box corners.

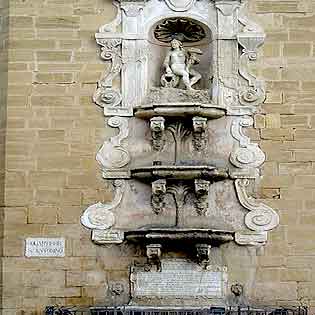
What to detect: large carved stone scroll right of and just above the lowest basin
<box><xmin>235</xmin><ymin>179</ymin><xmax>279</xmax><ymax>232</ymax></box>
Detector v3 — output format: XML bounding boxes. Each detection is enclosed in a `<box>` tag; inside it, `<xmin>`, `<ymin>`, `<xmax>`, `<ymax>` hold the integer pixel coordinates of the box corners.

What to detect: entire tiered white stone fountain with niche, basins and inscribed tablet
<box><xmin>81</xmin><ymin>0</ymin><xmax>279</xmax><ymax>305</ymax></box>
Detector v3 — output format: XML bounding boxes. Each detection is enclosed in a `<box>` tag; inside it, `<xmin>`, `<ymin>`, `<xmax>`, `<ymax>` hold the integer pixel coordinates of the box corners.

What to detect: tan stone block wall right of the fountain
<box><xmin>251</xmin><ymin>0</ymin><xmax>315</xmax><ymax>306</ymax></box>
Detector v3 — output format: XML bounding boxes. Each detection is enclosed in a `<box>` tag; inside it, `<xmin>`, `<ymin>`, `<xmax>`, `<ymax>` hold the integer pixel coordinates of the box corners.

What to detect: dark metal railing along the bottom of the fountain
<box><xmin>44</xmin><ymin>306</ymin><xmax>308</xmax><ymax>315</ymax></box>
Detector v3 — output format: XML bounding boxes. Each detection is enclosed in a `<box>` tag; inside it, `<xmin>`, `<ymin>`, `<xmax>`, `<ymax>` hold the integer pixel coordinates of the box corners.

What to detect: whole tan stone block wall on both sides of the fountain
<box><xmin>0</xmin><ymin>0</ymin><xmax>315</xmax><ymax>314</ymax></box>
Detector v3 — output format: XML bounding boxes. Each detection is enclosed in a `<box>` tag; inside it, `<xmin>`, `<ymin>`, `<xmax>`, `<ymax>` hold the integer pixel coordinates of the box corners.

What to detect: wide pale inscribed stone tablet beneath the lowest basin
<box><xmin>131</xmin><ymin>259</ymin><xmax>227</xmax><ymax>298</ymax></box>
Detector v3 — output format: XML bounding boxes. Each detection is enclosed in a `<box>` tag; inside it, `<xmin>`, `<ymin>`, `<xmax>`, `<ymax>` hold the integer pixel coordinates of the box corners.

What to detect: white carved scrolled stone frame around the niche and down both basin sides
<box><xmin>81</xmin><ymin>0</ymin><xmax>279</xmax><ymax>245</ymax></box>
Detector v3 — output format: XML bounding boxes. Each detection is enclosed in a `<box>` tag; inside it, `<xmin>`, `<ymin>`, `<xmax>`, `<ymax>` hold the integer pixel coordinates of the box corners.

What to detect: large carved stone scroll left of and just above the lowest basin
<box><xmin>81</xmin><ymin>180</ymin><xmax>125</xmax><ymax>230</ymax></box>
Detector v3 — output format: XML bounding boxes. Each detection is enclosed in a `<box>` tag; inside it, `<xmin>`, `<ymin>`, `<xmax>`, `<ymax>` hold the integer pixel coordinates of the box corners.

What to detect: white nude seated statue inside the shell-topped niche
<box><xmin>161</xmin><ymin>39</ymin><xmax>202</xmax><ymax>90</ymax></box>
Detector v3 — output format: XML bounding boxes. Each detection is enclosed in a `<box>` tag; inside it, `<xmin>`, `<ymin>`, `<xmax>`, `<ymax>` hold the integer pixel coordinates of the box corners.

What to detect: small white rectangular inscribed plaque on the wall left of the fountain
<box><xmin>25</xmin><ymin>237</ymin><xmax>65</xmax><ymax>257</ymax></box>
